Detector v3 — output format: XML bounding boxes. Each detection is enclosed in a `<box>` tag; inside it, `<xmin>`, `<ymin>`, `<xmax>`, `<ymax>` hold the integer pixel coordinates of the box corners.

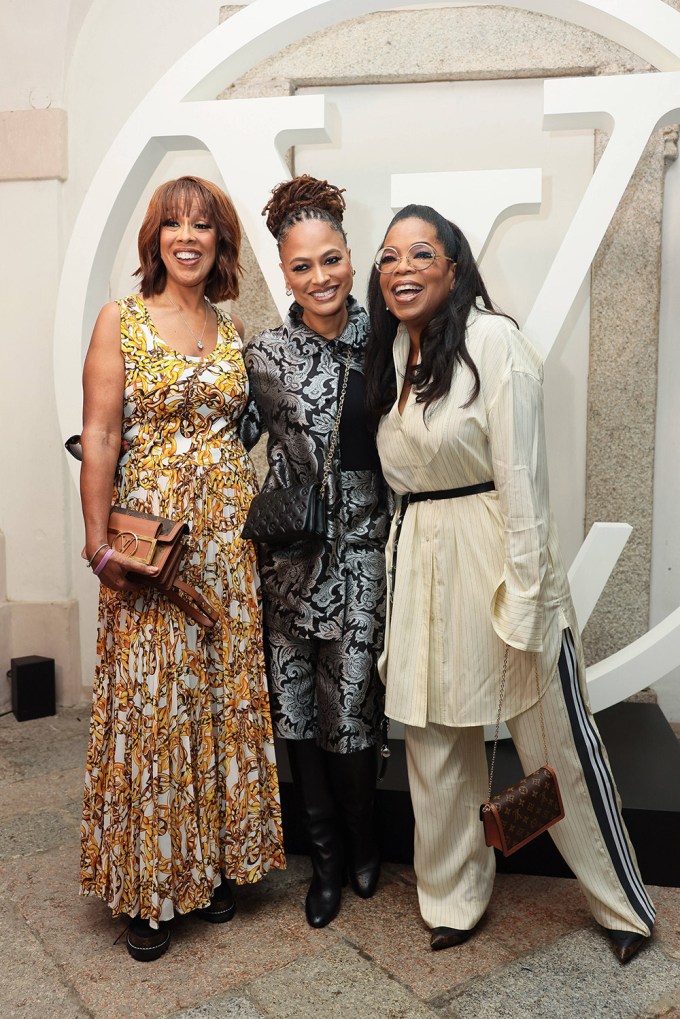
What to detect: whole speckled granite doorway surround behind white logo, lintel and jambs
<box><xmin>223</xmin><ymin>0</ymin><xmax>680</xmax><ymax>661</ymax></box>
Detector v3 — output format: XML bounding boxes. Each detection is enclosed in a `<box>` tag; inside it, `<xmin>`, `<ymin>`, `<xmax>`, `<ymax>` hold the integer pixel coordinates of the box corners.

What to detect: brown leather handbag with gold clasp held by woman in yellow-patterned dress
<box><xmin>107</xmin><ymin>506</ymin><xmax>219</xmax><ymax>630</ymax></box>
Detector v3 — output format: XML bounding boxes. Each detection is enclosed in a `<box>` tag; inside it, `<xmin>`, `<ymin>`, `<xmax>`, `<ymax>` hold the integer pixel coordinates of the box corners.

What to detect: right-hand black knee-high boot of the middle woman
<box><xmin>325</xmin><ymin>747</ymin><xmax>380</xmax><ymax>899</ymax></box>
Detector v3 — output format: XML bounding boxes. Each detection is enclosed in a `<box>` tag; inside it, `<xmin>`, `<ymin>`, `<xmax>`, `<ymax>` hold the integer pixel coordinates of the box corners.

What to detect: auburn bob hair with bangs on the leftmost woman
<box><xmin>135</xmin><ymin>177</ymin><xmax>243</xmax><ymax>302</ymax></box>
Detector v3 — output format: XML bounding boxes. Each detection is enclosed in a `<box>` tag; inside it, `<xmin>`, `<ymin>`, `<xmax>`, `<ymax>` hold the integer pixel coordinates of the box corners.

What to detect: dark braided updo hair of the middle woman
<box><xmin>262</xmin><ymin>173</ymin><xmax>347</xmax><ymax>252</ymax></box>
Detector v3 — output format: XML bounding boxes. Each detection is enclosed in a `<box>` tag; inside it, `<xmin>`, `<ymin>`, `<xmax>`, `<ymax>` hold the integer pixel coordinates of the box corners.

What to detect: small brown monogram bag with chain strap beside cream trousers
<box><xmin>479</xmin><ymin>646</ymin><xmax>565</xmax><ymax>856</ymax></box>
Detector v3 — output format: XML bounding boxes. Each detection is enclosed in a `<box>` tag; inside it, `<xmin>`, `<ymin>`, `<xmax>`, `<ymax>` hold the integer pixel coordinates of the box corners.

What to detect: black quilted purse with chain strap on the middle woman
<box><xmin>242</xmin><ymin>346</ymin><xmax>352</xmax><ymax>545</ymax></box>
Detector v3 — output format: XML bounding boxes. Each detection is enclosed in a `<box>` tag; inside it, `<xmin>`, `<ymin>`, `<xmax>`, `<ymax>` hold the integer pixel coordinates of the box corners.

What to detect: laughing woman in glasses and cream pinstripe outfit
<box><xmin>366</xmin><ymin>206</ymin><xmax>655</xmax><ymax>962</ymax></box>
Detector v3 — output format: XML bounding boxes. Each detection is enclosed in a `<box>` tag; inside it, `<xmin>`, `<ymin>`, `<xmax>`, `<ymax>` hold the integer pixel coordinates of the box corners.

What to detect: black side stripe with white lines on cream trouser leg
<box><xmin>559</xmin><ymin>630</ymin><xmax>656</xmax><ymax>929</ymax></box>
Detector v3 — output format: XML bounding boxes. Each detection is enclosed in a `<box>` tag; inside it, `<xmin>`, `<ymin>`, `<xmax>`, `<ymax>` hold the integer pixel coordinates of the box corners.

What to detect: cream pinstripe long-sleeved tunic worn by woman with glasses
<box><xmin>377</xmin><ymin>309</ymin><xmax>585</xmax><ymax>727</ymax></box>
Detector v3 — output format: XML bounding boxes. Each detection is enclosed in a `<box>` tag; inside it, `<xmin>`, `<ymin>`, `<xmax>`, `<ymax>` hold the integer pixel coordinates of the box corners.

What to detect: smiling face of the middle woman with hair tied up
<box><xmin>280</xmin><ymin>219</ymin><xmax>352</xmax><ymax>338</ymax></box>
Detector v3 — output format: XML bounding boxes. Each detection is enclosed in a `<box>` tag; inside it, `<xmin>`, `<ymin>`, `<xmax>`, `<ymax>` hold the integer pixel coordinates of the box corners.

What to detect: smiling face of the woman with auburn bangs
<box><xmin>159</xmin><ymin>203</ymin><xmax>217</xmax><ymax>286</ymax></box>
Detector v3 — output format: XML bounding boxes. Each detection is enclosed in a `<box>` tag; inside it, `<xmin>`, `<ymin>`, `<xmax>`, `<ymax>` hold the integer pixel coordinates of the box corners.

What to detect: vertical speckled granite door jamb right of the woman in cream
<box><xmin>584</xmin><ymin>130</ymin><xmax>677</xmax><ymax>661</ymax></box>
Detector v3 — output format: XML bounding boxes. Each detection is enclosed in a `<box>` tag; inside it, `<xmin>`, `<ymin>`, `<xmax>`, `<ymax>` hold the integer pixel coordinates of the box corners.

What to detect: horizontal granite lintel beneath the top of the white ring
<box><xmin>224</xmin><ymin>7</ymin><xmax>648</xmax><ymax>86</ymax></box>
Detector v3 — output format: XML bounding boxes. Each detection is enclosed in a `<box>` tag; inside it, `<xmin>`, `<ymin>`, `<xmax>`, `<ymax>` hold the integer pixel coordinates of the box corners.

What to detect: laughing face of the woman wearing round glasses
<box><xmin>380</xmin><ymin>218</ymin><xmax>456</xmax><ymax>342</ymax></box>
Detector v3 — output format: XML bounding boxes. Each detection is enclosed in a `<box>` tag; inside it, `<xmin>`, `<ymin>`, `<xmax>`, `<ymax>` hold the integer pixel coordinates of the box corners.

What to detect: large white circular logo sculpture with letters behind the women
<box><xmin>54</xmin><ymin>0</ymin><xmax>680</xmax><ymax>710</ymax></box>
